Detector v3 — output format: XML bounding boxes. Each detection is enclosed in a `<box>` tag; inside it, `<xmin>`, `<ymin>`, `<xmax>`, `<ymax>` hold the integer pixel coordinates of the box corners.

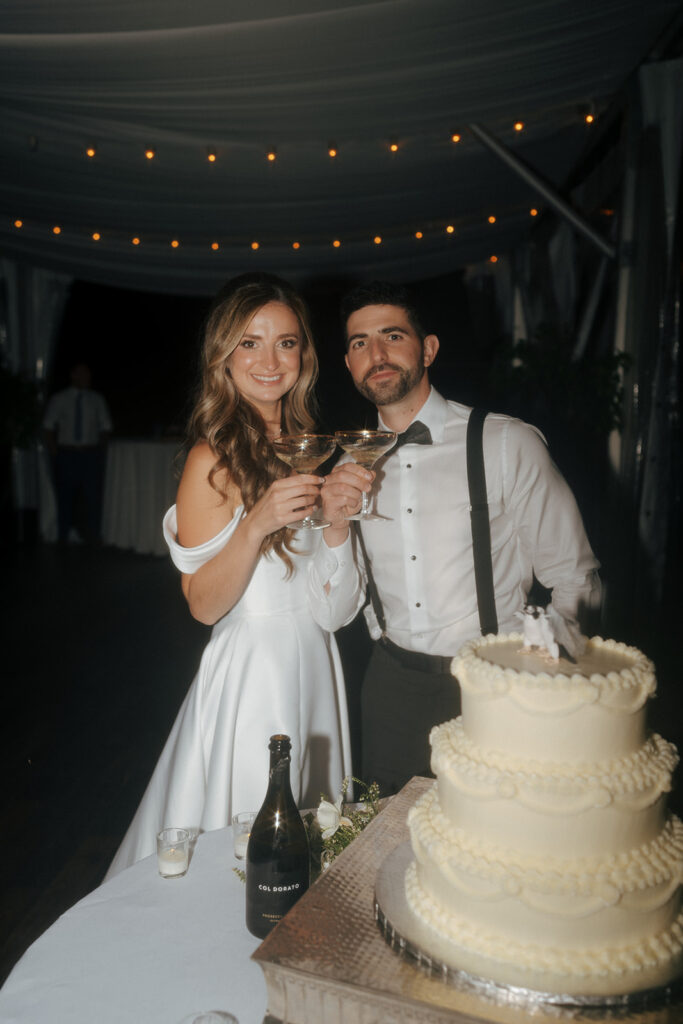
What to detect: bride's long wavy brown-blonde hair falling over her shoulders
<box><xmin>186</xmin><ymin>274</ymin><xmax>317</xmax><ymax>571</ymax></box>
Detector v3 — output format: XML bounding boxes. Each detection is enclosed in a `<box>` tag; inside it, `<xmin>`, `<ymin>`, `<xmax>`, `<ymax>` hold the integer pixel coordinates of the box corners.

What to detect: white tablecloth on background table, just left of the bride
<box><xmin>102</xmin><ymin>440</ymin><xmax>180</xmax><ymax>555</ymax></box>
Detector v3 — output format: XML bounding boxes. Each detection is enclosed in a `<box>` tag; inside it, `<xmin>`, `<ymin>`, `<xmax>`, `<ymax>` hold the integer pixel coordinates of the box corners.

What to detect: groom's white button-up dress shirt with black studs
<box><xmin>309</xmin><ymin>388</ymin><xmax>600</xmax><ymax>656</ymax></box>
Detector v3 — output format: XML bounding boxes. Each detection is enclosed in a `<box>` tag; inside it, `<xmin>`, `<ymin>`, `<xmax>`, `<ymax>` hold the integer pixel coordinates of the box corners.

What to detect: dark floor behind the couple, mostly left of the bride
<box><xmin>0</xmin><ymin>544</ymin><xmax>683</xmax><ymax>982</ymax></box>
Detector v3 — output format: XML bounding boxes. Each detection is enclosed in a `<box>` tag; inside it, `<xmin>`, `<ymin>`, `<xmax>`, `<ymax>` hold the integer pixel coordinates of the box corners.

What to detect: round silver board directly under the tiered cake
<box><xmin>375</xmin><ymin>843</ymin><xmax>683</xmax><ymax>1022</ymax></box>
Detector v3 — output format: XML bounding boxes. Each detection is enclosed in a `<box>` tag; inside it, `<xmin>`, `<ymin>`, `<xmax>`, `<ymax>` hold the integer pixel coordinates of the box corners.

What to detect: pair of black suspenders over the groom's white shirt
<box><xmin>356</xmin><ymin>409</ymin><xmax>498</xmax><ymax>636</ymax></box>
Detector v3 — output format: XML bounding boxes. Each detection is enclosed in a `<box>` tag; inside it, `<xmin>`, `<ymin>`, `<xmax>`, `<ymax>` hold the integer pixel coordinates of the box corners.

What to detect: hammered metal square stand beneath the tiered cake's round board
<box><xmin>253</xmin><ymin>777</ymin><xmax>683</xmax><ymax>1024</ymax></box>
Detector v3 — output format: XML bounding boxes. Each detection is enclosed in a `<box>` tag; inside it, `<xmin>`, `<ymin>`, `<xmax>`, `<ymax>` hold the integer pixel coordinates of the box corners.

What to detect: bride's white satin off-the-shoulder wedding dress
<box><xmin>105</xmin><ymin>506</ymin><xmax>351</xmax><ymax>879</ymax></box>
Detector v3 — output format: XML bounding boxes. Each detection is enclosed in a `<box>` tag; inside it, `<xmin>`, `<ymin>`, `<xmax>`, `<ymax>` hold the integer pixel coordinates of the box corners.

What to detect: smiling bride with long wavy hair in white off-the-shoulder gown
<box><xmin>106</xmin><ymin>275</ymin><xmax>351</xmax><ymax>879</ymax></box>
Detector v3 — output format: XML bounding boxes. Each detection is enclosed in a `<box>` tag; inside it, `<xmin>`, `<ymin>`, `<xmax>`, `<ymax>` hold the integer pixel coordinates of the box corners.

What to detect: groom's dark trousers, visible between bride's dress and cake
<box><xmin>360</xmin><ymin>643</ymin><xmax>460</xmax><ymax>796</ymax></box>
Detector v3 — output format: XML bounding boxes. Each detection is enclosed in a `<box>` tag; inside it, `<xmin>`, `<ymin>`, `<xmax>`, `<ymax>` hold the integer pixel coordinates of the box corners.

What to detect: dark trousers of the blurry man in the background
<box><xmin>54</xmin><ymin>447</ymin><xmax>103</xmax><ymax>543</ymax></box>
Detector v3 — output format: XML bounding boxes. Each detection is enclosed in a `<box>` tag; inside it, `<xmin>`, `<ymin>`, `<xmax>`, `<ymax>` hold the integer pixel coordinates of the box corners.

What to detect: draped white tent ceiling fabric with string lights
<box><xmin>0</xmin><ymin>0</ymin><xmax>680</xmax><ymax>294</ymax></box>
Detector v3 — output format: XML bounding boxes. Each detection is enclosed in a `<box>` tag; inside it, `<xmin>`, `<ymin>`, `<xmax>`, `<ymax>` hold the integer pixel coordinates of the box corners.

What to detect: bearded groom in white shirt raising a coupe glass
<box><xmin>309</xmin><ymin>283</ymin><xmax>600</xmax><ymax>794</ymax></box>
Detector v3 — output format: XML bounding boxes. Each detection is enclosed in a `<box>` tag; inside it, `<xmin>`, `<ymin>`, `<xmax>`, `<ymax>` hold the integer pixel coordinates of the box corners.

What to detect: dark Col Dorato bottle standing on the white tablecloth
<box><xmin>246</xmin><ymin>735</ymin><xmax>310</xmax><ymax>939</ymax></box>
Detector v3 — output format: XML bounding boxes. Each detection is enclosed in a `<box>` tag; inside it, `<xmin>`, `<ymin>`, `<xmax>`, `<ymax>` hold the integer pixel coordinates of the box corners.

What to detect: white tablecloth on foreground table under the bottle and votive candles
<box><xmin>0</xmin><ymin>828</ymin><xmax>266</xmax><ymax>1024</ymax></box>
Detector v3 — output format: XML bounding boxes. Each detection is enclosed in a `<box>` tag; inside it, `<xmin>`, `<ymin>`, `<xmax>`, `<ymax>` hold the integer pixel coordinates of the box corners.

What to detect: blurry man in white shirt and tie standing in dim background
<box><xmin>43</xmin><ymin>362</ymin><xmax>112</xmax><ymax>544</ymax></box>
